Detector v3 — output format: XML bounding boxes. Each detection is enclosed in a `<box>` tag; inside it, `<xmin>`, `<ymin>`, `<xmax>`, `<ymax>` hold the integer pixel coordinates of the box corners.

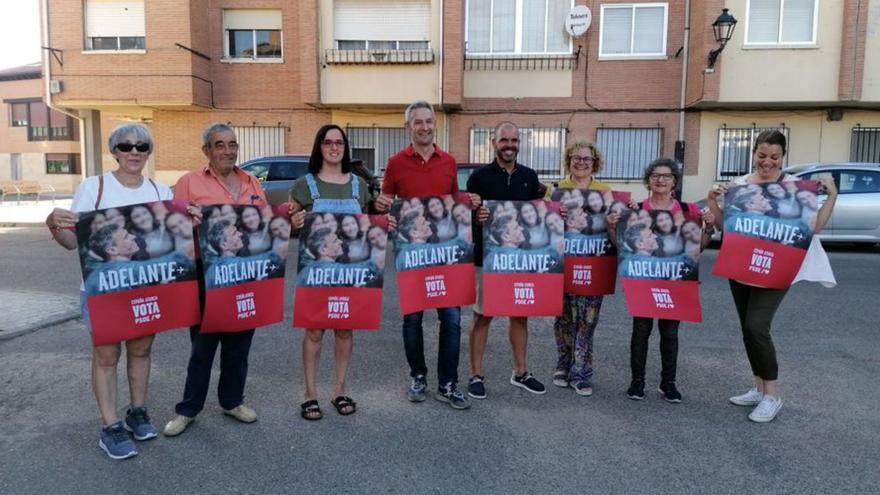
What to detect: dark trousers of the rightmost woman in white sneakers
<box><xmin>730</xmin><ymin>280</ymin><xmax>788</xmax><ymax>380</ymax></box>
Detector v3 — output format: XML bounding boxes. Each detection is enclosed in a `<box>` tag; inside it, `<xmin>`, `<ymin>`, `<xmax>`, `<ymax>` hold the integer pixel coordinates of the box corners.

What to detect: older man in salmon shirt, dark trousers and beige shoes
<box><xmin>164</xmin><ymin>124</ymin><xmax>266</xmax><ymax>437</ymax></box>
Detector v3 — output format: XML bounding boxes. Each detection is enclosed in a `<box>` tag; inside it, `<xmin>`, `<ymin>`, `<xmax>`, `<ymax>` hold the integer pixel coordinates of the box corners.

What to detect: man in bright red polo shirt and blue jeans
<box><xmin>376</xmin><ymin>101</ymin><xmax>480</xmax><ymax>409</ymax></box>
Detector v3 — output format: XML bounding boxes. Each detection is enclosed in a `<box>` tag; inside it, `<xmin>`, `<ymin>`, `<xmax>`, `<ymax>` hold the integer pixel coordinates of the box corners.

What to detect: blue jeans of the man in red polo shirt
<box><xmin>403</xmin><ymin>308</ymin><xmax>461</xmax><ymax>385</ymax></box>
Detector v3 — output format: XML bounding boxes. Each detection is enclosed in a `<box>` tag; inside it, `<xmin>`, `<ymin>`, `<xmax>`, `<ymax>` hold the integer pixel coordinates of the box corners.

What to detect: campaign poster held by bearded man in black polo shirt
<box><xmin>483</xmin><ymin>200</ymin><xmax>565</xmax><ymax>316</ymax></box>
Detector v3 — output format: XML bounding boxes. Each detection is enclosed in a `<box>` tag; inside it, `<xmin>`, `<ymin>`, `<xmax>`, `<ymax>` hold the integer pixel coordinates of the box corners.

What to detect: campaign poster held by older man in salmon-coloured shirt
<box><xmin>199</xmin><ymin>204</ymin><xmax>290</xmax><ymax>333</ymax></box>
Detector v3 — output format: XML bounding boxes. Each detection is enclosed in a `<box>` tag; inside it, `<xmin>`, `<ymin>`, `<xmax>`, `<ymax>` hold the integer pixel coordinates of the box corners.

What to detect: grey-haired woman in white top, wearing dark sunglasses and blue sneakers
<box><xmin>46</xmin><ymin>124</ymin><xmax>172</xmax><ymax>459</ymax></box>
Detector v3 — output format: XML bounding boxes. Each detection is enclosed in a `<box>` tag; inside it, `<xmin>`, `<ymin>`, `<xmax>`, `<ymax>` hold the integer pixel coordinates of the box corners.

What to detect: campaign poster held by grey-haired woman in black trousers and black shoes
<box><xmin>617</xmin><ymin>210</ymin><xmax>703</xmax><ymax>322</ymax></box>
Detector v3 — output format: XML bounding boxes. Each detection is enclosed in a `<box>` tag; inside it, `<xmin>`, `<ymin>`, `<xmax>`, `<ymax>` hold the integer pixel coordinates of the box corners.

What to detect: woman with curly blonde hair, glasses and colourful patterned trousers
<box><xmin>548</xmin><ymin>141</ymin><xmax>611</xmax><ymax>396</ymax></box>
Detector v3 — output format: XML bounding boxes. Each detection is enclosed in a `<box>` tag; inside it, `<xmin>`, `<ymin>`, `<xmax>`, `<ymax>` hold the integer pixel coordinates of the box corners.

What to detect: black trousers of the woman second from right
<box><xmin>629</xmin><ymin>317</ymin><xmax>681</xmax><ymax>382</ymax></box>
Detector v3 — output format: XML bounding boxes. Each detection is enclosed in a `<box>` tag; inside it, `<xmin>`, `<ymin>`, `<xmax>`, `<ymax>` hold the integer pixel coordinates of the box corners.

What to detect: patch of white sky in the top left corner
<box><xmin>0</xmin><ymin>0</ymin><xmax>40</xmax><ymax>69</ymax></box>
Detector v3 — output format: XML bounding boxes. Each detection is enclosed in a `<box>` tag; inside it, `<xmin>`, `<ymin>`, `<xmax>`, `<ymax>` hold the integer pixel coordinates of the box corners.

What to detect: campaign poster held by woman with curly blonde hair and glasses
<box><xmin>547</xmin><ymin>189</ymin><xmax>630</xmax><ymax>296</ymax></box>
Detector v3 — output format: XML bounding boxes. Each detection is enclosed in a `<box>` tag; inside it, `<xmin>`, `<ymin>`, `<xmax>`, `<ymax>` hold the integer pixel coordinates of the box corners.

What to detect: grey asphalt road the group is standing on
<box><xmin>0</xmin><ymin>229</ymin><xmax>880</xmax><ymax>494</ymax></box>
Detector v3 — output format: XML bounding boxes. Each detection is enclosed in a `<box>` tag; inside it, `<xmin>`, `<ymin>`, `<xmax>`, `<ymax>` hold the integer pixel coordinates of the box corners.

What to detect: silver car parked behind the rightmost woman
<box><xmin>784</xmin><ymin>162</ymin><xmax>880</xmax><ymax>243</ymax></box>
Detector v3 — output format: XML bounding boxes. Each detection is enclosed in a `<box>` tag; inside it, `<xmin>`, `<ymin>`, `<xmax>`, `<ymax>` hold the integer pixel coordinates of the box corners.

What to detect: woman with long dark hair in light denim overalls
<box><xmin>290</xmin><ymin>125</ymin><xmax>369</xmax><ymax>420</ymax></box>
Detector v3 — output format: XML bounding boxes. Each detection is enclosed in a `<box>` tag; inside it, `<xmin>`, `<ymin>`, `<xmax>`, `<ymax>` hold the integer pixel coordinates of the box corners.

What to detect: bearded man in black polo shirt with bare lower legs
<box><xmin>467</xmin><ymin>122</ymin><xmax>547</xmax><ymax>399</ymax></box>
